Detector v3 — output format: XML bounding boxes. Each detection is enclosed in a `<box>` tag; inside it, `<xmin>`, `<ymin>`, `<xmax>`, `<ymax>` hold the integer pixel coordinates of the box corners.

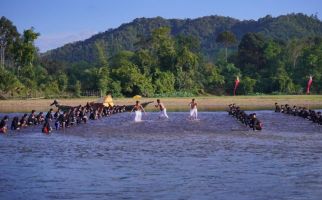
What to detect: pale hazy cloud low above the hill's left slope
<box><xmin>35</xmin><ymin>31</ymin><xmax>97</xmax><ymax>52</ymax></box>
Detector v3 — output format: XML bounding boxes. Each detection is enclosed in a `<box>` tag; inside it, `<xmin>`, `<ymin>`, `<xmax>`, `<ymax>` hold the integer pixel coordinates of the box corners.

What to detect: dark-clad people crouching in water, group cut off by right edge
<box><xmin>275</xmin><ymin>103</ymin><xmax>322</xmax><ymax>125</ymax></box>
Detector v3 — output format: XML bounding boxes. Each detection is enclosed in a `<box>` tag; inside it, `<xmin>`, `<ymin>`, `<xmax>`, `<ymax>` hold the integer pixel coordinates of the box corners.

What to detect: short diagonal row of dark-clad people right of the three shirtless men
<box><xmin>228</xmin><ymin>104</ymin><xmax>263</xmax><ymax>131</ymax></box>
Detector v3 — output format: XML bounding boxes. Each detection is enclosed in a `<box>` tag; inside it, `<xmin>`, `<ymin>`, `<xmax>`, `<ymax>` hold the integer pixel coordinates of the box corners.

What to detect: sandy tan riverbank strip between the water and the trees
<box><xmin>0</xmin><ymin>95</ymin><xmax>322</xmax><ymax>113</ymax></box>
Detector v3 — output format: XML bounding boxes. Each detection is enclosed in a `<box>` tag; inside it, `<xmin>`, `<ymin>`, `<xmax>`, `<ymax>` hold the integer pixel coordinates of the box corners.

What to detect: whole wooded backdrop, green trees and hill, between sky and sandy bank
<box><xmin>0</xmin><ymin>14</ymin><xmax>322</xmax><ymax>97</ymax></box>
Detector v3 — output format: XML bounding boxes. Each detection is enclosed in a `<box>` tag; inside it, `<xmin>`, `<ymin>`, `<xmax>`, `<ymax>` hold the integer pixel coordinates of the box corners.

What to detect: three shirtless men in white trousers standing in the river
<box><xmin>131</xmin><ymin>99</ymin><xmax>198</xmax><ymax>122</ymax></box>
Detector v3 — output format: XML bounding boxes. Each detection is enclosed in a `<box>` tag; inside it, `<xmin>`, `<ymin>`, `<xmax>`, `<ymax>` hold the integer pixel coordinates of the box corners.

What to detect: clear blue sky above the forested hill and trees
<box><xmin>0</xmin><ymin>0</ymin><xmax>322</xmax><ymax>52</ymax></box>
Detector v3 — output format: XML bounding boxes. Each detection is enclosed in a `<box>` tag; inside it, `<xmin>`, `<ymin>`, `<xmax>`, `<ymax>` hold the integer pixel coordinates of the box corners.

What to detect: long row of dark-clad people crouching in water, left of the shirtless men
<box><xmin>0</xmin><ymin>104</ymin><xmax>125</xmax><ymax>133</ymax></box>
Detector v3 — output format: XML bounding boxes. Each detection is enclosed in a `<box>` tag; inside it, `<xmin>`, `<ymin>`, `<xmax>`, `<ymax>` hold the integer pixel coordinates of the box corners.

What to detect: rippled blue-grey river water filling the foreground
<box><xmin>0</xmin><ymin>111</ymin><xmax>322</xmax><ymax>200</ymax></box>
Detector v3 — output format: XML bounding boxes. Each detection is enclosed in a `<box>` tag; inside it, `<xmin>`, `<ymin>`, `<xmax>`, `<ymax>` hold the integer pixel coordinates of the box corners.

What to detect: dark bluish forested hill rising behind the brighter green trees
<box><xmin>42</xmin><ymin>14</ymin><xmax>322</xmax><ymax>64</ymax></box>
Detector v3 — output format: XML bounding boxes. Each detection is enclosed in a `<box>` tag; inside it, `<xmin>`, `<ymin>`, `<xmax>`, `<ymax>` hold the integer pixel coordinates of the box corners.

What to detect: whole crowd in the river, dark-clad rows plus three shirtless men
<box><xmin>4</xmin><ymin>99</ymin><xmax>322</xmax><ymax>133</ymax></box>
